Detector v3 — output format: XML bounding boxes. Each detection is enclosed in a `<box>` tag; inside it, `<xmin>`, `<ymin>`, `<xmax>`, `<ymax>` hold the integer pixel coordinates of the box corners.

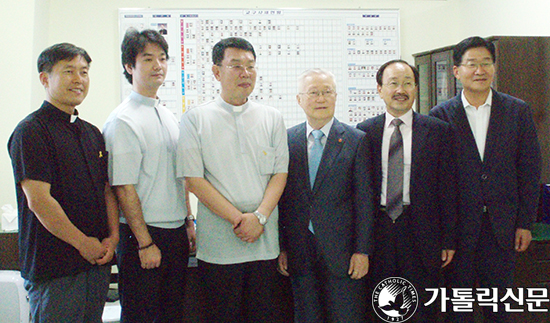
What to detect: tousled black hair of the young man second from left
<box><xmin>120</xmin><ymin>28</ymin><xmax>168</xmax><ymax>84</ymax></box>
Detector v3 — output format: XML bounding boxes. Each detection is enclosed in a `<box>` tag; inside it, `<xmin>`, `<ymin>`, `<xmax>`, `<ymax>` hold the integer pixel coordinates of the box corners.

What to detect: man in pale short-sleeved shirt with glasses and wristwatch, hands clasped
<box><xmin>178</xmin><ymin>38</ymin><xmax>288</xmax><ymax>322</ymax></box>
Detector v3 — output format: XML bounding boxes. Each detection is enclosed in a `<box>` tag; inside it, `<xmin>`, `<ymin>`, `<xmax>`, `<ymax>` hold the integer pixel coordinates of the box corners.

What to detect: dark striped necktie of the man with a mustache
<box><xmin>386</xmin><ymin>119</ymin><xmax>404</xmax><ymax>221</ymax></box>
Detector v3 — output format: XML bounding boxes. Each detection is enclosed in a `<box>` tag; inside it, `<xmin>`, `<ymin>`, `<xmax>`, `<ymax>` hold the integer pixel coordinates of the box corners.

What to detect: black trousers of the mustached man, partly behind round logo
<box><xmin>368</xmin><ymin>208</ymin><xmax>441</xmax><ymax>322</ymax></box>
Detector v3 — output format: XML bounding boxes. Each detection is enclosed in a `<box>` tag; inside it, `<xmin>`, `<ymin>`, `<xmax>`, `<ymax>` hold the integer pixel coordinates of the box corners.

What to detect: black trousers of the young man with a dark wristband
<box><xmin>117</xmin><ymin>223</ymin><xmax>189</xmax><ymax>323</ymax></box>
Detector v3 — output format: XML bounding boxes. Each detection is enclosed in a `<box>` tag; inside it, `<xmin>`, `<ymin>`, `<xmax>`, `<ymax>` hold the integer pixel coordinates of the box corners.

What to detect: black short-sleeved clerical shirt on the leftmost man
<box><xmin>8</xmin><ymin>101</ymin><xmax>108</xmax><ymax>281</ymax></box>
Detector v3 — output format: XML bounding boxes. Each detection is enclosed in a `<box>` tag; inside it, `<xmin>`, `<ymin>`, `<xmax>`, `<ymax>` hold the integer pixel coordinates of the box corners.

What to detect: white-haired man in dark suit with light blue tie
<box><xmin>279</xmin><ymin>69</ymin><xmax>372</xmax><ymax>323</ymax></box>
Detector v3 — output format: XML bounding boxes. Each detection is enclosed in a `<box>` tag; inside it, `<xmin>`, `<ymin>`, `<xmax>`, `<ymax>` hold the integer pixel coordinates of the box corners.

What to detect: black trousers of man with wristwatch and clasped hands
<box><xmin>198</xmin><ymin>259</ymin><xmax>288</xmax><ymax>323</ymax></box>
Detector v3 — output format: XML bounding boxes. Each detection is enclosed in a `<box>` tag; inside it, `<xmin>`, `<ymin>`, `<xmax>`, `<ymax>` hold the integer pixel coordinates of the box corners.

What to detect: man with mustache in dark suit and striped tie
<box><xmin>357</xmin><ymin>60</ymin><xmax>457</xmax><ymax>322</ymax></box>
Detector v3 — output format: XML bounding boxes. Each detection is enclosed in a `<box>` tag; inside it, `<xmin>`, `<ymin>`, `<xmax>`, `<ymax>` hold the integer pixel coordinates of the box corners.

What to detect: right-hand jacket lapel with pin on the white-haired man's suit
<box><xmin>313</xmin><ymin>119</ymin><xmax>345</xmax><ymax>192</ymax></box>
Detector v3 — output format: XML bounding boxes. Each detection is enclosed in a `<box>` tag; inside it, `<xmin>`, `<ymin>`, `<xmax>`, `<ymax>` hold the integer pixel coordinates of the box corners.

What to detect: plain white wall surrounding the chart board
<box><xmin>0</xmin><ymin>0</ymin><xmax>550</xmax><ymax>209</ymax></box>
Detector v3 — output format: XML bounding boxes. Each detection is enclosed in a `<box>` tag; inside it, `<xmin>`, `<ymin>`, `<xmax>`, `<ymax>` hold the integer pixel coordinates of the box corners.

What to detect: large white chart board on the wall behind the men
<box><xmin>119</xmin><ymin>9</ymin><xmax>400</xmax><ymax>127</ymax></box>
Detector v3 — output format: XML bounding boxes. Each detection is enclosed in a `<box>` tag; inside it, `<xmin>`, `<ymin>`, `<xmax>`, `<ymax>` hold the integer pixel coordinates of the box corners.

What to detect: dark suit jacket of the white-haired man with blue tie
<box><xmin>279</xmin><ymin>119</ymin><xmax>372</xmax><ymax>277</ymax></box>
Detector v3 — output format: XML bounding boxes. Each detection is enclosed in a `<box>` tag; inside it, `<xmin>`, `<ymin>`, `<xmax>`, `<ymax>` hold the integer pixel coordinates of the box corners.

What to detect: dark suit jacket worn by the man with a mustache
<box><xmin>357</xmin><ymin>113</ymin><xmax>458</xmax><ymax>270</ymax></box>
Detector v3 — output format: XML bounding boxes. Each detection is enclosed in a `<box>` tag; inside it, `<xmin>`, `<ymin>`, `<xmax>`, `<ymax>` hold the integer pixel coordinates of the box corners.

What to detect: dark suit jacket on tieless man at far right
<box><xmin>430</xmin><ymin>90</ymin><xmax>541</xmax><ymax>250</ymax></box>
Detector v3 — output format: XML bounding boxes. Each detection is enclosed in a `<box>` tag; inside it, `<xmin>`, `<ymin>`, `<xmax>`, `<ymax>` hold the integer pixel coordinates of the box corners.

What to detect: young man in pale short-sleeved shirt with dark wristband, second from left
<box><xmin>103</xmin><ymin>29</ymin><xmax>194</xmax><ymax>323</ymax></box>
